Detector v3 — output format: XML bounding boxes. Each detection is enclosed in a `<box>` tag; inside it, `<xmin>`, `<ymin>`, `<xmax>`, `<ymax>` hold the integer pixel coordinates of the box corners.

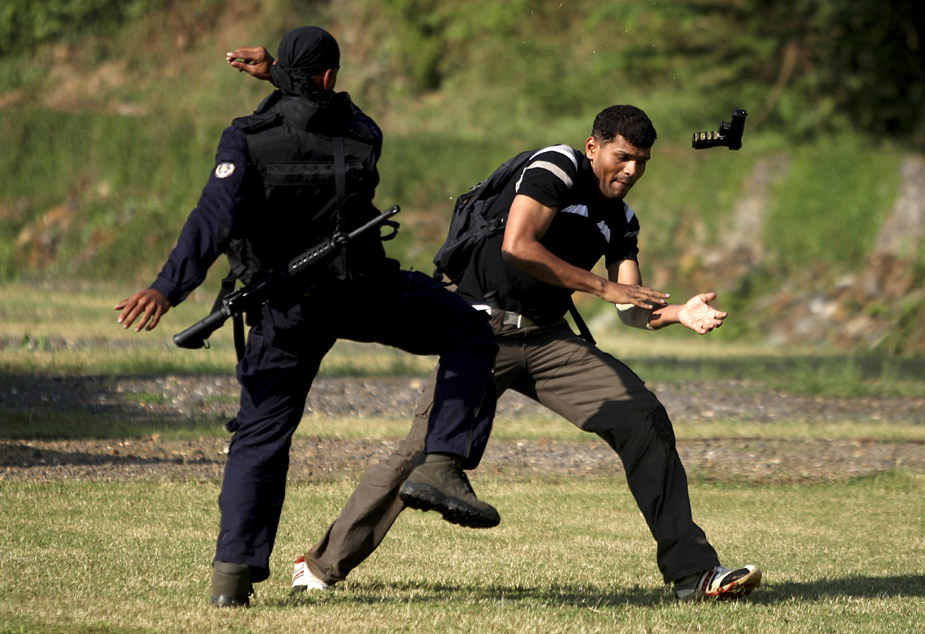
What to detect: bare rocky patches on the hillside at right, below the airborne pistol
<box><xmin>684</xmin><ymin>155</ymin><xmax>925</xmax><ymax>352</ymax></box>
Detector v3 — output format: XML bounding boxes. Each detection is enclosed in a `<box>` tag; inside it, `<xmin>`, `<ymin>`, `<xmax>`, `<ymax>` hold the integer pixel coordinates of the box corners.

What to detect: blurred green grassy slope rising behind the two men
<box><xmin>0</xmin><ymin>0</ymin><xmax>925</xmax><ymax>349</ymax></box>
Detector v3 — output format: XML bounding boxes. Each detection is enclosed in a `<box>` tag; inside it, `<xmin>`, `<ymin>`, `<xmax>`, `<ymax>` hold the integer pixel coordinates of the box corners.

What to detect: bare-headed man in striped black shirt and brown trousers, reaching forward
<box><xmin>293</xmin><ymin>106</ymin><xmax>761</xmax><ymax>601</ymax></box>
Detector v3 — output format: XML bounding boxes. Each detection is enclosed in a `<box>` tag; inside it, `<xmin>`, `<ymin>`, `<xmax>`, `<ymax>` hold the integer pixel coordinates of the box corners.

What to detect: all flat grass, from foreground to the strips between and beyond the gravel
<box><xmin>0</xmin><ymin>285</ymin><xmax>925</xmax><ymax>634</ymax></box>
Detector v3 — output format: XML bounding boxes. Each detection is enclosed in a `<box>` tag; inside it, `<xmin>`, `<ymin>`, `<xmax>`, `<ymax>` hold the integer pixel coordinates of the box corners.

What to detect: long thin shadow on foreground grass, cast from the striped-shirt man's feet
<box><xmin>278</xmin><ymin>575</ymin><xmax>925</xmax><ymax>608</ymax></box>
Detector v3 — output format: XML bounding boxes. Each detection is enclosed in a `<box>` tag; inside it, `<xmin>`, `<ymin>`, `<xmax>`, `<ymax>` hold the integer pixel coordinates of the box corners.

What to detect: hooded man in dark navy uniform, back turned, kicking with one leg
<box><xmin>115</xmin><ymin>27</ymin><xmax>499</xmax><ymax>607</ymax></box>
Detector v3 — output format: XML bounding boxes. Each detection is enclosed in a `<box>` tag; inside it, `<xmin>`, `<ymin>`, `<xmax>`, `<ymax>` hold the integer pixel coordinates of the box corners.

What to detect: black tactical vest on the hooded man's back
<box><xmin>228</xmin><ymin>91</ymin><xmax>385</xmax><ymax>284</ymax></box>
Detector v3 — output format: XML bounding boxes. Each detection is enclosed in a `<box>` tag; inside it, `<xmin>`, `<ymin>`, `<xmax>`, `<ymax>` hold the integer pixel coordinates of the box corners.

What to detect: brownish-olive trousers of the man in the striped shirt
<box><xmin>305</xmin><ymin>316</ymin><xmax>719</xmax><ymax>584</ymax></box>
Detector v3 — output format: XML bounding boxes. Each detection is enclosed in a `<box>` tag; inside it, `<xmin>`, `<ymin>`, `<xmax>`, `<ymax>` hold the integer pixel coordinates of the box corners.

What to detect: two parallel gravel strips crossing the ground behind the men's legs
<box><xmin>0</xmin><ymin>376</ymin><xmax>925</xmax><ymax>483</ymax></box>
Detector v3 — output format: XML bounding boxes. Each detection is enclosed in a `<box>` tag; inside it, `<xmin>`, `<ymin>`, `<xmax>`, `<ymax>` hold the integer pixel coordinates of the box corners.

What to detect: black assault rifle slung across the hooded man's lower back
<box><xmin>173</xmin><ymin>205</ymin><xmax>400</xmax><ymax>350</ymax></box>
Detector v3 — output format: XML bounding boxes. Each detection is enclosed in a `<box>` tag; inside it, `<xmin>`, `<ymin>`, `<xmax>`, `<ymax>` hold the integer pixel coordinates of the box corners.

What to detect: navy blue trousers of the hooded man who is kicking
<box><xmin>215</xmin><ymin>271</ymin><xmax>498</xmax><ymax>582</ymax></box>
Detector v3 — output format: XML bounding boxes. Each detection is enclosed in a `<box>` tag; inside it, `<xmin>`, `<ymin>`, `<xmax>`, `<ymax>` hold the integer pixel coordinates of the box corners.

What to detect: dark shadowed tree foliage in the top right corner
<box><xmin>620</xmin><ymin>0</ymin><xmax>925</xmax><ymax>144</ymax></box>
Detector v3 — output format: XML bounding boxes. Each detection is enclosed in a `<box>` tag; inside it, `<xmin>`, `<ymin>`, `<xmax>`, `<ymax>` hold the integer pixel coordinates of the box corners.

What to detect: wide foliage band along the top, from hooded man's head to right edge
<box><xmin>368</xmin><ymin>0</ymin><xmax>925</xmax><ymax>143</ymax></box>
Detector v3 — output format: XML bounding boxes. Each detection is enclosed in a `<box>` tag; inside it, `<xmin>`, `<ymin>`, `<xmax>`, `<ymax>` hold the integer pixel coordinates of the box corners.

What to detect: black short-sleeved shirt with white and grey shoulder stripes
<box><xmin>457</xmin><ymin>145</ymin><xmax>639</xmax><ymax>324</ymax></box>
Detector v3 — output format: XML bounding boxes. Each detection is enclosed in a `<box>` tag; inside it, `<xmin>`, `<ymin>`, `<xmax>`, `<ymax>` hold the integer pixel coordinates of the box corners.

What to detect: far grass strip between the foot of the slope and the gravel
<box><xmin>0</xmin><ymin>278</ymin><xmax>925</xmax><ymax>398</ymax></box>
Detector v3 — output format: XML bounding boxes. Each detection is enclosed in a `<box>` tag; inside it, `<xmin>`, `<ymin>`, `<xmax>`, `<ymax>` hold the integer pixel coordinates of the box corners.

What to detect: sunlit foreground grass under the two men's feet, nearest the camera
<box><xmin>0</xmin><ymin>473</ymin><xmax>925</xmax><ymax>633</ymax></box>
